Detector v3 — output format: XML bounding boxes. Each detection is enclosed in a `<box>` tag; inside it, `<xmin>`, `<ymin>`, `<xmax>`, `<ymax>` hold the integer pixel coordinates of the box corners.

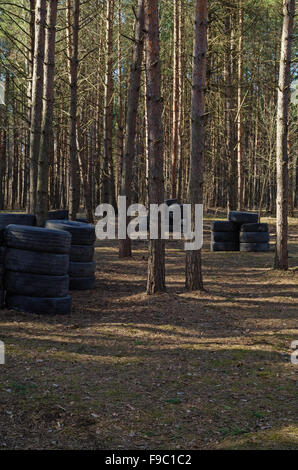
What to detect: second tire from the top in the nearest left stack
<box><xmin>5</xmin><ymin>248</ymin><xmax>69</xmax><ymax>276</ymax></box>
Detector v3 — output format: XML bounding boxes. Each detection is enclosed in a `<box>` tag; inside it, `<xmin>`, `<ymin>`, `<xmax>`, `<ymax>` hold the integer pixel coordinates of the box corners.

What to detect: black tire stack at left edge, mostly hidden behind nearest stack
<box><xmin>0</xmin><ymin>213</ymin><xmax>36</xmax><ymax>308</ymax></box>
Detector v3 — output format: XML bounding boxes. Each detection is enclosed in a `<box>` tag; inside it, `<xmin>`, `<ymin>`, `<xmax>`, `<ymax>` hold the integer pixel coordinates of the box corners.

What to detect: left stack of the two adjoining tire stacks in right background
<box><xmin>211</xmin><ymin>220</ymin><xmax>239</xmax><ymax>251</ymax></box>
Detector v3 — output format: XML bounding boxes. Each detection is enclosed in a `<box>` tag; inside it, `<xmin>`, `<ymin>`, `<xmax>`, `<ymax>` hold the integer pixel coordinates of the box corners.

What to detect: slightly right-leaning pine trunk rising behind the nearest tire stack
<box><xmin>36</xmin><ymin>0</ymin><xmax>58</xmax><ymax>227</ymax></box>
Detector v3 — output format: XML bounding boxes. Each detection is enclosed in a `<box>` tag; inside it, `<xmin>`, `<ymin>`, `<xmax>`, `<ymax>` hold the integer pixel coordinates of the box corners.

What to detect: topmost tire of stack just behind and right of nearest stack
<box><xmin>46</xmin><ymin>220</ymin><xmax>96</xmax><ymax>245</ymax></box>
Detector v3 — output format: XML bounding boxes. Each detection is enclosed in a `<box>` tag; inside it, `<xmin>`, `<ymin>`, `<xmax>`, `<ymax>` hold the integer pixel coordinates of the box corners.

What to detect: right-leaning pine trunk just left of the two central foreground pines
<box><xmin>119</xmin><ymin>0</ymin><xmax>144</xmax><ymax>258</ymax></box>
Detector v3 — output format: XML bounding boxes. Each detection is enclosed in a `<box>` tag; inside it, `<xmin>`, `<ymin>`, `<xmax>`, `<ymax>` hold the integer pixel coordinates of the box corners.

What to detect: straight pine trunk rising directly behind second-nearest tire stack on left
<box><xmin>66</xmin><ymin>0</ymin><xmax>80</xmax><ymax>220</ymax></box>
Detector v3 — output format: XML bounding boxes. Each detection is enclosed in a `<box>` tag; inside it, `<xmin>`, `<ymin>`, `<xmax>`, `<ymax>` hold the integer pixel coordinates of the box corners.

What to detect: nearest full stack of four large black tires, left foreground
<box><xmin>5</xmin><ymin>225</ymin><xmax>71</xmax><ymax>315</ymax></box>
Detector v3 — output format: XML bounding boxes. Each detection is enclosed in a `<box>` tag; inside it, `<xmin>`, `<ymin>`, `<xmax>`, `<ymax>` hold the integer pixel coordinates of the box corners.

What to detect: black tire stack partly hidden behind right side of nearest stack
<box><xmin>46</xmin><ymin>220</ymin><xmax>96</xmax><ymax>290</ymax></box>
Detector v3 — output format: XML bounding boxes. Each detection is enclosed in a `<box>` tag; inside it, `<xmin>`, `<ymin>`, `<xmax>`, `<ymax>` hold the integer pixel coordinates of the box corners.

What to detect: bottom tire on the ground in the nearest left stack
<box><xmin>6</xmin><ymin>294</ymin><xmax>71</xmax><ymax>315</ymax></box>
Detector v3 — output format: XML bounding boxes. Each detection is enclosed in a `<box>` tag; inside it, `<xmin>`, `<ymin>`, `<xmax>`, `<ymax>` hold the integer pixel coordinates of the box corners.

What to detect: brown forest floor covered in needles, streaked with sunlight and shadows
<box><xmin>0</xmin><ymin>216</ymin><xmax>298</xmax><ymax>449</ymax></box>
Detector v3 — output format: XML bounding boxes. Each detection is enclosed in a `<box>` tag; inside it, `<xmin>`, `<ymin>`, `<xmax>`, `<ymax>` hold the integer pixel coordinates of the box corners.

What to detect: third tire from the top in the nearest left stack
<box><xmin>5</xmin><ymin>271</ymin><xmax>69</xmax><ymax>297</ymax></box>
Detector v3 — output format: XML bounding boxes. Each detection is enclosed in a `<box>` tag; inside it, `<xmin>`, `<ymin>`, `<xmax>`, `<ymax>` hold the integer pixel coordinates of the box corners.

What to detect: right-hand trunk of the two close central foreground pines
<box><xmin>185</xmin><ymin>0</ymin><xmax>208</xmax><ymax>290</ymax></box>
